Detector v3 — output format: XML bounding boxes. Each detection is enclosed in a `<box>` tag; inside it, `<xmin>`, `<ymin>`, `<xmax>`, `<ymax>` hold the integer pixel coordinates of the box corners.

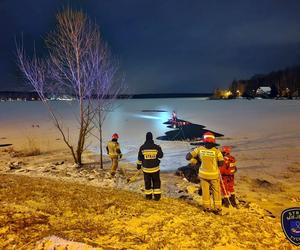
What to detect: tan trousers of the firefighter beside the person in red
<box><xmin>200</xmin><ymin>178</ymin><xmax>222</xmax><ymax>209</ymax></box>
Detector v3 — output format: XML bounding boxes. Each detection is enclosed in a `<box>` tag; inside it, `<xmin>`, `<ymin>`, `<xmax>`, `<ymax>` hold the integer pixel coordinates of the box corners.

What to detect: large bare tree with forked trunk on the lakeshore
<box><xmin>17</xmin><ymin>9</ymin><xmax>122</xmax><ymax>165</ymax></box>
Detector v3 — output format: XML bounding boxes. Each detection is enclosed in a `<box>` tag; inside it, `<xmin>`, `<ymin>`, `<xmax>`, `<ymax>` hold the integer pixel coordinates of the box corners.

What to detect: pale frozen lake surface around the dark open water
<box><xmin>0</xmin><ymin>98</ymin><xmax>300</xmax><ymax>170</ymax></box>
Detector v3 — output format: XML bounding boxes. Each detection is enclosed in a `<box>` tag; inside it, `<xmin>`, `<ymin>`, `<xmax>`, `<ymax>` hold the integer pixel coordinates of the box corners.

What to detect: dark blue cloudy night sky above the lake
<box><xmin>0</xmin><ymin>0</ymin><xmax>300</xmax><ymax>93</ymax></box>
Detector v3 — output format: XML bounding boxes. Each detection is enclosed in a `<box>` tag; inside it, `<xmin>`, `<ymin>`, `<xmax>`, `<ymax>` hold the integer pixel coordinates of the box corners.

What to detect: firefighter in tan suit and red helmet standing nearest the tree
<box><xmin>106</xmin><ymin>133</ymin><xmax>122</xmax><ymax>177</ymax></box>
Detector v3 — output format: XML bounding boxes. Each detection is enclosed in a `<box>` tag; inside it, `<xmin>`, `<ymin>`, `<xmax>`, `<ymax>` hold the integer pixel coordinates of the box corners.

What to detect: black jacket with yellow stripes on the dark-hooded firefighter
<box><xmin>137</xmin><ymin>140</ymin><xmax>163</xmax><ymax>173</ymax></box>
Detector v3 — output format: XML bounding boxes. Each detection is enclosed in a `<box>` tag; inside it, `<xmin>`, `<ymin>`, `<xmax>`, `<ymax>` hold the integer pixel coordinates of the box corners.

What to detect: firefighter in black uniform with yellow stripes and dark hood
<box><xmin>137</xmin><ymin>132</ymin><xmax>163</xmax><ymax>201</ymax></box>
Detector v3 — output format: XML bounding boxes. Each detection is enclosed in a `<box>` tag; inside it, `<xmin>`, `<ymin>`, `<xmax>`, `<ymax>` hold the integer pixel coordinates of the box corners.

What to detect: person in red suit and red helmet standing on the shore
<box><xmin>220</xmin><ymin>146</ymin><xmax>237</xmax><ymax>207</ymax></box>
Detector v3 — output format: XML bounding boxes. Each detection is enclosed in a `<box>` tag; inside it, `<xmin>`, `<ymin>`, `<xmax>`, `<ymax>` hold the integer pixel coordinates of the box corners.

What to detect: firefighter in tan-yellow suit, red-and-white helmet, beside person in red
<box><xmin>186</xmin><ymin>132</ymin><xmax>224</xmax><ymax>214</ymax></box>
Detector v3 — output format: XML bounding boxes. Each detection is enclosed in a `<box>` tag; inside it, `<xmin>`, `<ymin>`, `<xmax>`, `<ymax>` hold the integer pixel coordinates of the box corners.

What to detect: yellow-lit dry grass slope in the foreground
<box><xmin>0</xmin><ymin>174</ymin><xmax>290</xmax><ymax>249</ymax></box>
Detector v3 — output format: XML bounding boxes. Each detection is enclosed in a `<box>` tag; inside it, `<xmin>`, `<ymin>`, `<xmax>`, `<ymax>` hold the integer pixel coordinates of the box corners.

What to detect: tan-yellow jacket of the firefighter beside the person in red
<box><xmin>188</xmin><ymin>146</ymin><xmax>224</xmax><ymax>180</ymax></box>
